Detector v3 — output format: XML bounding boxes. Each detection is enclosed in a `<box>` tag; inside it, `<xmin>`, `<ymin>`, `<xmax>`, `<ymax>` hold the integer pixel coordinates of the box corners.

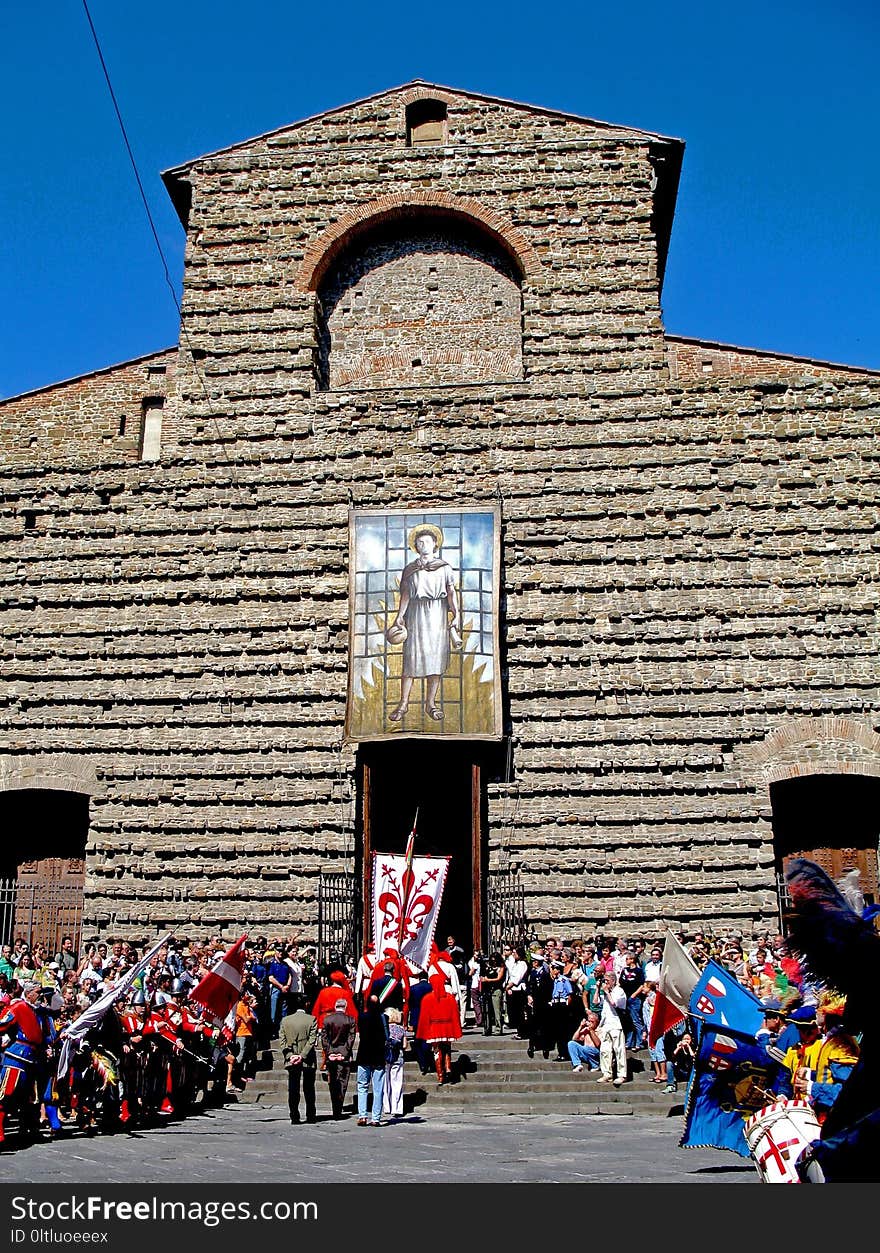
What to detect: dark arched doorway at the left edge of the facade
<box><xmin>0</xmin><ymin>788</ymin><xmax>89</xmax><ymax>954</ymax></box>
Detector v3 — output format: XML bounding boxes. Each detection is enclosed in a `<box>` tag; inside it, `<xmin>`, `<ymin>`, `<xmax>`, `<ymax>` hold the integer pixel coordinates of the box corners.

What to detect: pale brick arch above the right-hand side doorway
<box><xmin>735</xmin><ymin>715</ymin><xmax>880</xmax><ymax>787</ymax></box>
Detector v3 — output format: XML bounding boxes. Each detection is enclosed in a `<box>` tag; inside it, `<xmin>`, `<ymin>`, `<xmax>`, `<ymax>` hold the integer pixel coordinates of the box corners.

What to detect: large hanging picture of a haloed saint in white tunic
<box><xmin>346</xmin><ymin>506</ymin><xmax>500</xmax><ymax>741</ymax></box>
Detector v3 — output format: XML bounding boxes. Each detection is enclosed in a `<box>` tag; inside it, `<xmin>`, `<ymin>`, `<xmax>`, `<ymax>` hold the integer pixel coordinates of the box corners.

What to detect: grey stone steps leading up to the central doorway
<box><xmin>239</xmin><ymin>1026</ymin><xmax>684</xmax><ymax>1118</ymax></box>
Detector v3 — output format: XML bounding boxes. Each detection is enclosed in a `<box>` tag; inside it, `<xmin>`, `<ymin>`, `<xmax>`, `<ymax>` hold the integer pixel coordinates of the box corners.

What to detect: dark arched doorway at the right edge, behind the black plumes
<box><xmin>770</xmin><ymin>774</ymin><xmax>880</xmax><ymax>926</ymax></box>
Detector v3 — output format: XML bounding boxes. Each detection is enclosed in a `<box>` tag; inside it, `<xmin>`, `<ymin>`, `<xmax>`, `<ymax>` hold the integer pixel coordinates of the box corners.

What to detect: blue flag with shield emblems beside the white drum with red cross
<box><xmin>679</xmin><ymin>961</ymin><xmax>786</xmax><ymax>1158</ymax></box>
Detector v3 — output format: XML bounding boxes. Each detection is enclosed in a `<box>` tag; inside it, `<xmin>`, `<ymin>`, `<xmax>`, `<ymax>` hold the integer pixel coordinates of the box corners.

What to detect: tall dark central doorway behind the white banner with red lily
<box><xmin>360</xmin><ymin>741</ymin><xmax>484</xmax><ymax>951</ymax></box>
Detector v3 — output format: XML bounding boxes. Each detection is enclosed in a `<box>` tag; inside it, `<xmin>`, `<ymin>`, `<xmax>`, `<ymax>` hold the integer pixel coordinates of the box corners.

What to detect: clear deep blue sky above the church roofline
<box><xmin>0</xmin><ymin>0</ymin><xmax>880</xmax><ymax>396</ymax></box>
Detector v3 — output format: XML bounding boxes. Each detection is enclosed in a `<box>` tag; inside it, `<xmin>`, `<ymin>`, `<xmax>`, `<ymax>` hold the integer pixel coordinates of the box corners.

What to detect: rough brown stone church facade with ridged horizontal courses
<box><xmin>0</xmin><ymin>84</ymin><xmax>880</xmax><ymax>935</ymax></box>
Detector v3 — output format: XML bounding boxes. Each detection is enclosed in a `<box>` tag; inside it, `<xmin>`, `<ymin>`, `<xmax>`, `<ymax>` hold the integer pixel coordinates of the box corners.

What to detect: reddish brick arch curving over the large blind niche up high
<box><xmin>296</xmin><ymin>192</ymin><xmax>542</xmax><ymax>292</ymax></box>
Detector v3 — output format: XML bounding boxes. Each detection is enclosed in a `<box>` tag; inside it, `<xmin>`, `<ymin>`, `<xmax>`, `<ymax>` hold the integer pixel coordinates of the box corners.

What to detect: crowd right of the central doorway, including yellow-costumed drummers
<box><xmin>461</xmin><ymin>931</ymin><xmax>859</xmax><ymax>1104</ymax></box>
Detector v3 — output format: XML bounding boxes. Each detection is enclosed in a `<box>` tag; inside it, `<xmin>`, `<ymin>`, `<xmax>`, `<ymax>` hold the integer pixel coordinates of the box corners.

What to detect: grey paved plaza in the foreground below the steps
<box><xmin>0</xmin><ymin>1105</ymin><xmax>758</xmax><ymax>1184</ymax></box>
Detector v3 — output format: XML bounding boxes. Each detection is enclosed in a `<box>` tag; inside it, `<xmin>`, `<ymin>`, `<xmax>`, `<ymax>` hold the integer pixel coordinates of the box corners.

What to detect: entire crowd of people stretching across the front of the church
<box><xmin>0</xmin><ymin>931</ymin><xmax>854</xmax><ymax>1143</ymax></box>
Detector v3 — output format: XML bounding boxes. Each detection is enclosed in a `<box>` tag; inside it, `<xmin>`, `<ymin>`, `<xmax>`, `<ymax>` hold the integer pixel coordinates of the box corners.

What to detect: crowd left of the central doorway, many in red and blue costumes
<box><xmin>0</xmin><ymin>936</ymin><xmax>320</xmax><ymax>1144</ymax></box>
